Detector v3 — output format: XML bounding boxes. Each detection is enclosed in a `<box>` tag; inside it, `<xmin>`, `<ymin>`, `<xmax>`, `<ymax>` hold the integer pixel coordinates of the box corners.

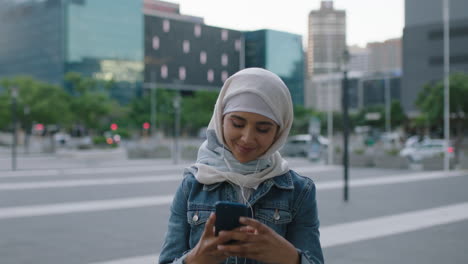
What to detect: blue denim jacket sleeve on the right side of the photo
<box><xmin>286</xmin><ymin>179</ymin><xmax>324</xmax><ymax>264</ymax></box>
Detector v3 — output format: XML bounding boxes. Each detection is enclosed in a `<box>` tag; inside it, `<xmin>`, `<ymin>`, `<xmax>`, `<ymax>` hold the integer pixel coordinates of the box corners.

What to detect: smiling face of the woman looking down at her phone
<box><xmin>223</xmin><ymin>112</ymin><xmax>278</xmax><ymax>163</ymax></box>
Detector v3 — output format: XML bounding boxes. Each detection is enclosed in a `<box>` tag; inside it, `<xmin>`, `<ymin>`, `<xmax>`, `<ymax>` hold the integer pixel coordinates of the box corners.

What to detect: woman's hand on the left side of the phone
<box><xmin>185</xmin><ymin>213</ymin><xmax>229</xmax><ymax>264</ymax></box>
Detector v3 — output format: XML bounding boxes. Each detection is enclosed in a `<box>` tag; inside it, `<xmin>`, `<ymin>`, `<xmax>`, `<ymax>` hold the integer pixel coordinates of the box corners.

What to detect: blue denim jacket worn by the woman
<box><xmin>159</xmin><ymin>170</ymin><xmax>324</xmax><ymax>264</ymax></box>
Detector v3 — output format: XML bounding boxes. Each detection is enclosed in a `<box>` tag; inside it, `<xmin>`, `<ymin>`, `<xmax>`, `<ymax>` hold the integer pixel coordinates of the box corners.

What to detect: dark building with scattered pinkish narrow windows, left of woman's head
<box><xmin>144</xmin><ymin>15</ymin><xmax>243</xmax><ymax>90</ymax></box>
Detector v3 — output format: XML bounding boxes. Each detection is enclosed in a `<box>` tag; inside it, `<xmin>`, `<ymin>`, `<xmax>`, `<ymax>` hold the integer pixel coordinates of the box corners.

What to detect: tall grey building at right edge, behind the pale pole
<box><xmin>401</xmin><ymin>0</ymin><xmax>468</xmax><ymax>113</ymax></box>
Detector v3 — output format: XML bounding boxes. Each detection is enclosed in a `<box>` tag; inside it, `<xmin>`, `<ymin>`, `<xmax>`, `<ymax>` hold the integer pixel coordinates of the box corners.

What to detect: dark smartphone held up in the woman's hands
<box><xmin>215</xmin><ymin>201</ymin><xmax>249</xmax><ymax>235</ymax></box>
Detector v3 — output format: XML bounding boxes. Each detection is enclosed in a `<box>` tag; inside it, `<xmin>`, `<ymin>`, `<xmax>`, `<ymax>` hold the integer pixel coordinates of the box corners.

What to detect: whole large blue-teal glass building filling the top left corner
<box><xmin>0</xmin><ymin>0</ymin><xmax>143</xmax><ymax>101</ymax></box>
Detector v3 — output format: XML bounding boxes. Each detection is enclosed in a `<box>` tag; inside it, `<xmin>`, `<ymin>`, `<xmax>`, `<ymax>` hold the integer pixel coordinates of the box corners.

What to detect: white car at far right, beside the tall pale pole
<box><xmin>400</xmin><ymin>139</ymin><xmax>453</xmax><ymax>162</ymax></box>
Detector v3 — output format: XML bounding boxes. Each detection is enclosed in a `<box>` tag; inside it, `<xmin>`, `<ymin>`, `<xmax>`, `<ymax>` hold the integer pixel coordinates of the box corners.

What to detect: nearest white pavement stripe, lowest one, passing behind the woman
<box><xmin>87</xmin><ymin>203</ymin><xmax>468</xmax><ymax>264</ymax></box>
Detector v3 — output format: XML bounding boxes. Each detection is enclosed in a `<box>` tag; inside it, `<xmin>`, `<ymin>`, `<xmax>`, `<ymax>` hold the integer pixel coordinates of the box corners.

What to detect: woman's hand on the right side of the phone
<box><xmin>218</xmin><ymin>217</ymin><xmax>300</xmax><ymax>264</ymax></box>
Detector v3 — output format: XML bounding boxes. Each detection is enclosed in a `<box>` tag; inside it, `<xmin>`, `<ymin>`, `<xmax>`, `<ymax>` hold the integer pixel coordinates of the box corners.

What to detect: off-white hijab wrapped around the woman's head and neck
<box><xmin>187</xmin><ymin>68</ymin><xmax>294</xmax><ymax>188</ymax></box>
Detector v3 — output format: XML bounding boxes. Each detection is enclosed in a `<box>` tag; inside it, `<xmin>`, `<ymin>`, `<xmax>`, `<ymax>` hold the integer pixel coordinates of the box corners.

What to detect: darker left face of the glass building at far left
<box><xmin>0</xmin><ymin>0</ymin><xmax>65</xmax><ymax>84</ymax></box>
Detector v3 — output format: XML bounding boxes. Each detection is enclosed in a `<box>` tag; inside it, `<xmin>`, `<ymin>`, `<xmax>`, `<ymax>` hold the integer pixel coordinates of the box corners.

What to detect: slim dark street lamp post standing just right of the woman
<box><xmin>342</xmin><ymin>48</ymin><xmax>350</xmax><ymax>202</ymax></box>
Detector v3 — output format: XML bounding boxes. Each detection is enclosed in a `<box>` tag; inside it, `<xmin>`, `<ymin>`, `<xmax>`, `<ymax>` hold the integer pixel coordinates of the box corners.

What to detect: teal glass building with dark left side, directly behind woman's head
<box><xmin>244</xmin><ymin>30</ymin><xmax>304</xmax><ymax>105</ymax></box>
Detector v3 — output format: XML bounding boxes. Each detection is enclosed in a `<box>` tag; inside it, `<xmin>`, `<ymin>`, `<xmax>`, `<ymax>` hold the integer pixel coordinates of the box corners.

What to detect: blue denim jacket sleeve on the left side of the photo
<box><xmin>159</xmin><ymin>177</ymin><xmax>190</xmax><ymax>264</ymax></box>
